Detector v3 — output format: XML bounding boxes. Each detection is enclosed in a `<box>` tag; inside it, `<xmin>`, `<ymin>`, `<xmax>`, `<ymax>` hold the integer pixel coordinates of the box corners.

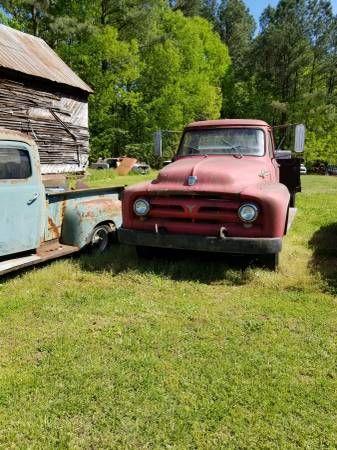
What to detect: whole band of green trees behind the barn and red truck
<box><xmin>0</xmin><ymin>0</ymin><xmax>337</xmax><ymax>161</ymax></box>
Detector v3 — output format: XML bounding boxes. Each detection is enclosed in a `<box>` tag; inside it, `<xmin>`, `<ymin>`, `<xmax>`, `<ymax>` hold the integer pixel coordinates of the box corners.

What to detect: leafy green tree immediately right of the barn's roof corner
<box><xmin>58</xmin><ymin>25</ymin><xmax>140</xmax><ymax>158</ymax></box>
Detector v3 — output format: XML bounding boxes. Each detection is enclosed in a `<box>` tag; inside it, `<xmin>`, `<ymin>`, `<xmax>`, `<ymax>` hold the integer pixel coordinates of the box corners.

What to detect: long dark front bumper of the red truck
<box><xmin>118</xmin><ymin>228</ymin><xmax>282</xmax><ymax>255</ymax></box>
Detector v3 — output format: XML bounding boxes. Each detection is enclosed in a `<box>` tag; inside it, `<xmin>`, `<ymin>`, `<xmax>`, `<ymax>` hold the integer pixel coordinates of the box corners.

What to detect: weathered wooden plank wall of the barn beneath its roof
<box><xmin>0</xmin><ymin>75</ymin><xmax>89</xmax><ymax>174</ymax></box>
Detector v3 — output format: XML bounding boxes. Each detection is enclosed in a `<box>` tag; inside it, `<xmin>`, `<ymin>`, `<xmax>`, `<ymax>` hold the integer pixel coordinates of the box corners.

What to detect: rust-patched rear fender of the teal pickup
<box><xmin>61</xmin><ymin>198</ymin><xmax>122</xmax><ymax>249</ymax></box>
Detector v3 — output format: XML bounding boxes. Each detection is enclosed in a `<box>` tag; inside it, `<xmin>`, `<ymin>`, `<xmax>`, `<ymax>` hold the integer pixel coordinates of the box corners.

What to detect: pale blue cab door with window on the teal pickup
<box><xmin>0</xmin><ymin>140</ymin><xmax>43</xmax><ymax>257</ymax></box>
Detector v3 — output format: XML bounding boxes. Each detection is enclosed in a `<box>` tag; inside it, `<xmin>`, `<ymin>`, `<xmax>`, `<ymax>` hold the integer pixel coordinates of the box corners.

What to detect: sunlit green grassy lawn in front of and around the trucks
<box><xmin>0</xmin><ymin>173</ymin><xmax>337</xmax><ymax>449</ymax></box>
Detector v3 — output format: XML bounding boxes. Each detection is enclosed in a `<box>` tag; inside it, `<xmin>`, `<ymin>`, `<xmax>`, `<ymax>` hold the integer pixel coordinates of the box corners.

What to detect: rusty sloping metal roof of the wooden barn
<box><xmin>0</xmin><ymin>24</ymin><xmax>93</xmax><ymax>93</ymax></box>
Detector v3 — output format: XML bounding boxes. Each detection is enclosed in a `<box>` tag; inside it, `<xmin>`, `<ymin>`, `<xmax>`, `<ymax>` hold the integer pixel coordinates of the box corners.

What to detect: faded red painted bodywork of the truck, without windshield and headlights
<box><xmin>122</xmin><ymin>119</ymin><xmax>290</xmax><ymax>238</ymax></box>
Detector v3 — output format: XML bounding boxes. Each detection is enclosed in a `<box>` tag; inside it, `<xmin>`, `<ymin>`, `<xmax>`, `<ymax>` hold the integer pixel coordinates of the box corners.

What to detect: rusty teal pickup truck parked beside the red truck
<box><xmin>0</xmin><ymin>129</ymin><xmax>123</xmax><ymax>275</ymax></box>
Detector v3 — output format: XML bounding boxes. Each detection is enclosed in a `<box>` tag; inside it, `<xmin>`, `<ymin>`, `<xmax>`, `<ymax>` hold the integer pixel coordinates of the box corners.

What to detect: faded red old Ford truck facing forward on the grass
<box><xmin>118</xmin><ymin>120</ymin><xmax>304</xmax><ymax>269</ymax></box>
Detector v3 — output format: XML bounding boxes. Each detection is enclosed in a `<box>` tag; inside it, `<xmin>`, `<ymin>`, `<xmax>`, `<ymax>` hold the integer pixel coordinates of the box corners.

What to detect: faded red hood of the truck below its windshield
<box><xmin>150</xmin><ymin>155</ymin><xmax>270</xmax><ymax>193</ymax></box>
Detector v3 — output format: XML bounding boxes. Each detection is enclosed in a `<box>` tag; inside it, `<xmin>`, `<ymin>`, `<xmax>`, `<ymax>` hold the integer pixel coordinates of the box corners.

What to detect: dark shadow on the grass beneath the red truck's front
<box><xmin>79</xmin><ymin>244</ymin><xmax>266</xmax><ymax>285</ymax></box>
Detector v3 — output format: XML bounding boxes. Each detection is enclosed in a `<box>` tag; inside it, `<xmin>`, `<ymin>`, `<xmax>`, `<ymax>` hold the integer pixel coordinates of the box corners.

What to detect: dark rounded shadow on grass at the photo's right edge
<box><xmin>309</xmin><ymin>223</ymin><xmax>337</xmax><ymax>295</ymax></box>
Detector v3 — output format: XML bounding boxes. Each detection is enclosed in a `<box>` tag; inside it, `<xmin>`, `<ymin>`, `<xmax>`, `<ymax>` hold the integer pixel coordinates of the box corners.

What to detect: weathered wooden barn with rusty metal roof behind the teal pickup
<box><xmin>0</xmin><ymin>25</ymin><xmax>92</xmax><ymax>174</ymax></box>
